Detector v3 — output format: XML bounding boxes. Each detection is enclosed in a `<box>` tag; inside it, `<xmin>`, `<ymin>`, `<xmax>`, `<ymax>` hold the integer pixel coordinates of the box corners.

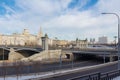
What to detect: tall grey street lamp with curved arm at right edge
<box><xmin>101</xmin><ymin>13</ymin><xmax>120</xmax><ymax>70</ymax></box>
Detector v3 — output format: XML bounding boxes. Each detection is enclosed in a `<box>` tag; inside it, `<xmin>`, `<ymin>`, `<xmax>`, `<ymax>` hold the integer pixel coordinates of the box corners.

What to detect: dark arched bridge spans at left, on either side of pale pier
<box><xmin>0</xmin><ymin>47</ymin><xmax>42</xmax><ymax>60</ymax></box>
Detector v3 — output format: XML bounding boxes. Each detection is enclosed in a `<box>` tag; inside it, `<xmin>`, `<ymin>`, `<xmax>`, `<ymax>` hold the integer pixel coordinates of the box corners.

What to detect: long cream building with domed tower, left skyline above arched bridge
<box><xmin>0</xmin><ymin>29</ymin><xmax>42</xmax><ymax>46</ymax></box>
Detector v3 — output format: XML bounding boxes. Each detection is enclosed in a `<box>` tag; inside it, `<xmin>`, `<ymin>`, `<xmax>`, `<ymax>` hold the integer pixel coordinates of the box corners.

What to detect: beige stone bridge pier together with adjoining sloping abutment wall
<box><xmin>8</xmin><ymin>48</ymin><xmax>66</xmax><ymax>61</ymax></box>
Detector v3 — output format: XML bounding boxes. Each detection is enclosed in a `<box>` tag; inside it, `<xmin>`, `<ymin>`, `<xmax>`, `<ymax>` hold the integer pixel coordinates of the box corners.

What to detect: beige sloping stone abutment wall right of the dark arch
<box><xmin>21</xmin><ymin>50</ymin><xmax>66</xmax><ymax>61</ymax></box>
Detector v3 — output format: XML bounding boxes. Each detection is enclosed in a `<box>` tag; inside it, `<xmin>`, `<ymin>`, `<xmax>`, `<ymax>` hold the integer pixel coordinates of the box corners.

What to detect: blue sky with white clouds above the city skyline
<box><xmin>0</xmin><ymin>0</ymin><xmax>120</xmax><ymax>41</ymax></box>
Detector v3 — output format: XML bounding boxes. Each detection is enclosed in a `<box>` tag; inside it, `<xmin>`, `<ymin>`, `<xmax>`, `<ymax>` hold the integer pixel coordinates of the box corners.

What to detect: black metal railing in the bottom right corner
<box><xmin>67</xmin><ymin>70</ymin><xmax>120</xmax><ymax>80</ymax></box>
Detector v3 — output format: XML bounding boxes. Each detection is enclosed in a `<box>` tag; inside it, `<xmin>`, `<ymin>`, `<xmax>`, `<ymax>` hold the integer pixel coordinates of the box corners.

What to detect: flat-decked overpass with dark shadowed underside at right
<box><xmin>64</xmin><ymin>49</ymin><xmax>118</xmax><ymax>62</ymax></box>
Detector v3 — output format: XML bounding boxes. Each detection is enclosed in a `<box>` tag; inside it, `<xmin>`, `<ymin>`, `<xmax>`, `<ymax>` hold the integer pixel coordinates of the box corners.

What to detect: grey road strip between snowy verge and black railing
<box><xmin>40</xmin><ymin>63</ymin><xmax>117</xmax><ymax>80</ymax></box>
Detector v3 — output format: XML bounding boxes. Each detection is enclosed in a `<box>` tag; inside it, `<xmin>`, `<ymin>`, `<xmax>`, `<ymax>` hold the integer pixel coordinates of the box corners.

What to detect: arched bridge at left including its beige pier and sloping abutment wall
<box><xmin>0</xmin><ymin>47</ymin><xmax>65</xmax><ymax>61</ymax></box>
